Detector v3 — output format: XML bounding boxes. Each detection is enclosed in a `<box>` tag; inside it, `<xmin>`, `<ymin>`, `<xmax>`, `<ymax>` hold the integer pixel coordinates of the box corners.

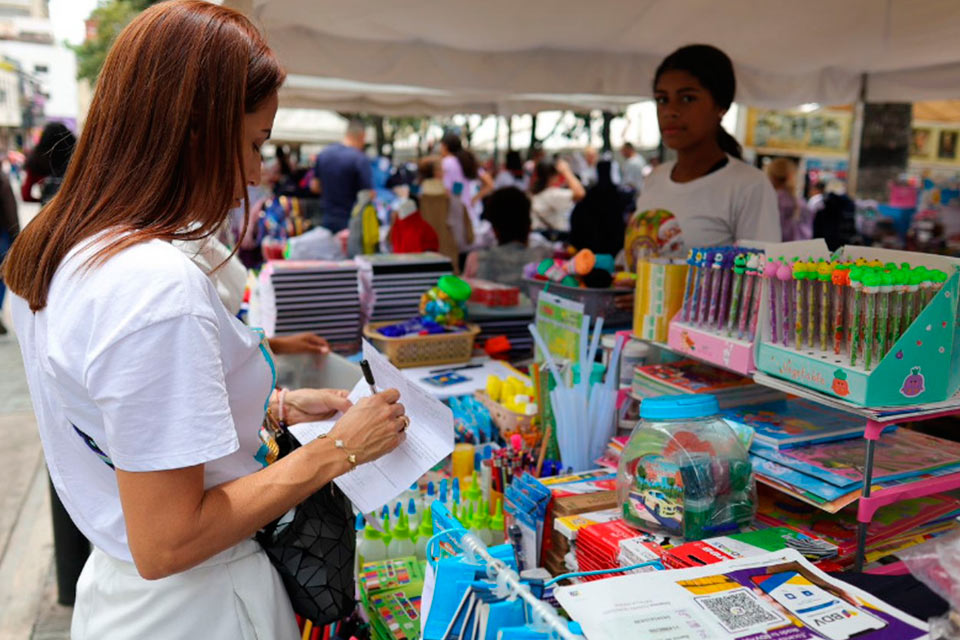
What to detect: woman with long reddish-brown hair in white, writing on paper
<box><xmin>4</xmin><ymin>0</ymin><xmax>409</xmax><ymax>640</ymax></box>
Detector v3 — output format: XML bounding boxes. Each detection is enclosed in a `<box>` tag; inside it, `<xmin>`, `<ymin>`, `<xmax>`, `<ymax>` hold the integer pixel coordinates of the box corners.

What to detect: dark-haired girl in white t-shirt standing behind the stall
<box><xmin>626</xmin><ymin>45</ymin><xmax>780</xmax><ymax>265</ymax></box>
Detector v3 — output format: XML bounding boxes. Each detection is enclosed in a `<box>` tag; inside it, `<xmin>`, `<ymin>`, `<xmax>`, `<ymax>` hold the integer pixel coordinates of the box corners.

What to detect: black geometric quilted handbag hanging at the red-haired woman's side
<box><xmin>257</xmin><ymin>429</ymin><xmax>356</xmax><ymax>625</ymax></box>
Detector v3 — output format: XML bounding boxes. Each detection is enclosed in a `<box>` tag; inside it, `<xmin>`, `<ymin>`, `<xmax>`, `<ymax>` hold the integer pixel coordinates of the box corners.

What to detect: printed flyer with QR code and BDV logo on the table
<box><xmin>556</xmin><ymin>549</ymin><xmax>927</xmax><ymax>640</ymax></box>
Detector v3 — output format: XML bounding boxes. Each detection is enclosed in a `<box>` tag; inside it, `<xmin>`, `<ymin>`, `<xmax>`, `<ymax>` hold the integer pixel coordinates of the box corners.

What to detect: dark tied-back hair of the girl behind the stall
<box><xmin>653</xmin><ymin>44</ymin><xmax>743</xmax><ymax>160</ymax></box>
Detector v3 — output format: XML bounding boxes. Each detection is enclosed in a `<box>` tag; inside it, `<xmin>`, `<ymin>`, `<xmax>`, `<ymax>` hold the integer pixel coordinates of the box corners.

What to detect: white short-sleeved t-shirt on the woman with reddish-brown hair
<box><xmin>11</xmin><ymin>235</ymin><xmax>274</xmax><ymax>561</ymax></box>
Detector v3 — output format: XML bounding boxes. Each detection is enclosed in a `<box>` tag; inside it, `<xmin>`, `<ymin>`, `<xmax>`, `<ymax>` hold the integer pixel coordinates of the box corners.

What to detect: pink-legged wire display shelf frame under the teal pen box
<box><xmin>753</xmin><ymin>372</ymin><xmax>960</xmax><ymax>571</ymax></box>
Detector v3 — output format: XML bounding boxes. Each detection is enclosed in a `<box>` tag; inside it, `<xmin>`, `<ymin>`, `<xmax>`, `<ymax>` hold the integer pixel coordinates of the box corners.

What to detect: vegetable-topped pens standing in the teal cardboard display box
<box><xmin>763</xmin><ymin>257</ymin><xmax>947</xmax><ymax>371</ymax></box>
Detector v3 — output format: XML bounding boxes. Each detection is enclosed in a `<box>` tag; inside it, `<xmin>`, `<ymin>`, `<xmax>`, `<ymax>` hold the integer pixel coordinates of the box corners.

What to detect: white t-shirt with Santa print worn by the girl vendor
<box><xmin>627</xmin><ymin>156</ymin><xmax>781</xmax><ymax>256</ymax></box>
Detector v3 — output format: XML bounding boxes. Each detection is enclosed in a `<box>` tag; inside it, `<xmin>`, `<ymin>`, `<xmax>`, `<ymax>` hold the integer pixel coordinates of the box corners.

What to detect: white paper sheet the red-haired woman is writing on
<box><xmin>290</xmin><ymin>340</ymin><xmax>453</xmax><ymax>513</ymax></box>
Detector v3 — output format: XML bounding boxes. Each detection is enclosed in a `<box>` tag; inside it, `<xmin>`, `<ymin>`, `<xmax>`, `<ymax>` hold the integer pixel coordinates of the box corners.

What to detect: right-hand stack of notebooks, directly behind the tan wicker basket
<box><xmin>356</xmin><ymin>253</ymin><xmax>453</xmax><ymax>322</ymax></box>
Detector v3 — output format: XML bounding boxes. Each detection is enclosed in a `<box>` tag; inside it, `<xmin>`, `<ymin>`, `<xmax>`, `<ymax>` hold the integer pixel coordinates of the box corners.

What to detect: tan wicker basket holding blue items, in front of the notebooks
<box><xmin>363</xmin><ymin>322</ymin><xmax>480</xmax><ymax>369</ymax></box>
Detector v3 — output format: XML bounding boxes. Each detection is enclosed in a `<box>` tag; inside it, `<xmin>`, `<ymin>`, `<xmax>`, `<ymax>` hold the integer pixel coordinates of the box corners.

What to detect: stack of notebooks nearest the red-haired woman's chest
<box><xmin>260</xmin><ymin>260</ymin><xmax>360</xmax><ymax>353</ymax></box>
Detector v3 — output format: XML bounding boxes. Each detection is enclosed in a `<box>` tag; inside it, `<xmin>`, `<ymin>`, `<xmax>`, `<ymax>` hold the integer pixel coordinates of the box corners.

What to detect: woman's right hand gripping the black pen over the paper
<box><xmin>328</xmin><ymin>389</ymin><xmax>410</xmax><ymax>464</ymax></box>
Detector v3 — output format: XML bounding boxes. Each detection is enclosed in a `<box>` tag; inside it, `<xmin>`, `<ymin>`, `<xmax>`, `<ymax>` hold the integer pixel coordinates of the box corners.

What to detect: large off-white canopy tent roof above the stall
<box><xmin>224</xmin><ymin>0</ymin><xmax>960</xmax><ymax>113</ymax></box>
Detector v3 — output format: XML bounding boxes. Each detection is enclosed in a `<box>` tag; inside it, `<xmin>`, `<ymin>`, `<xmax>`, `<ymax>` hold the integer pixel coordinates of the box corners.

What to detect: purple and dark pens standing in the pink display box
<box><xmin>680</xmin><ymin>247</ymin><xmax>764</xmax><ymax>340</ymax></box>
